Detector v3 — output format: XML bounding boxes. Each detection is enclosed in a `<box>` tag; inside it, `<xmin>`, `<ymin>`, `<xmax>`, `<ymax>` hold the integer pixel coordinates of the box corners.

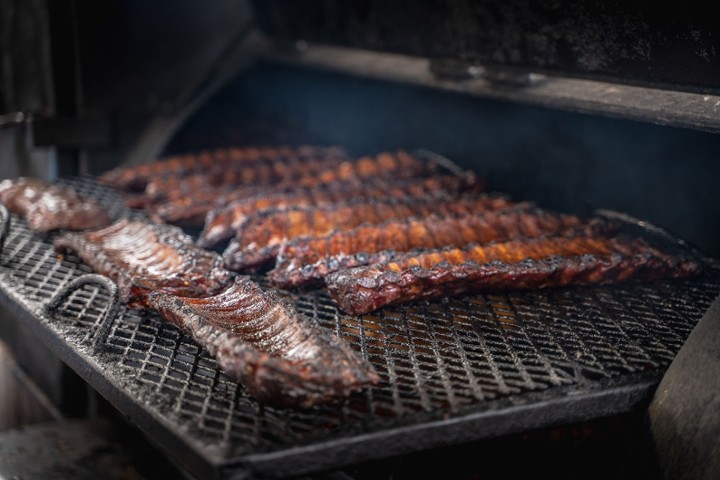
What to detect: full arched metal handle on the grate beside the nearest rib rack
<box><xmin>44</xmin><ymin>273</ymin><xmax>120</xmax><ymax>352</ymax></box>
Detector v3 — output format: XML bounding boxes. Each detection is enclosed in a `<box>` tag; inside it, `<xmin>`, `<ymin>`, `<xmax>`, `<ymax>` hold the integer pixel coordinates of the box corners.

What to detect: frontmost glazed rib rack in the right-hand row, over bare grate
<box><xmin>325</xmin><ymin>236</ymin><xmax>701</xmax><ymax>314</ymax></box>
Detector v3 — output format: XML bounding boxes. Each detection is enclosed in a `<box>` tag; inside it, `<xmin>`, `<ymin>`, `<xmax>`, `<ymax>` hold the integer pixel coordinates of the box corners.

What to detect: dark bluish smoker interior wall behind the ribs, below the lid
<box><xmin>165</xmin><ymin>64</ymin><xmax>720</xmax><ymax>257</ymax></box>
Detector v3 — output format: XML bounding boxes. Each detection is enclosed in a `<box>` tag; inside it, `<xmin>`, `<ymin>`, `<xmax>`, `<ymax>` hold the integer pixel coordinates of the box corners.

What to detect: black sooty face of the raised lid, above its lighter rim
<box><xmin>253</xmin><ymin>0</ymin><xmax>720</xmax><ymax>92</ymax></box>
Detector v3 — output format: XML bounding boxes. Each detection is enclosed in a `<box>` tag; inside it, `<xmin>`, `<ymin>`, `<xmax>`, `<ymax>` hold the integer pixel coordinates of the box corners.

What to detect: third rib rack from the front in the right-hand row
<box><xmin>223</xmin><ymin>194</ymin><xmax>510</xmax><ymax>270</ymax></box>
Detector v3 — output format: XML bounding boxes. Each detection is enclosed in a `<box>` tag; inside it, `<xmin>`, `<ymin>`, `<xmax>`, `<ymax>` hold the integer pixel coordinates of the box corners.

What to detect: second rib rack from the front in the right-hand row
<box><xmin>268</xmin><ymin>207</ymin><xmax>616</xmax><ymax>288</ymax></box>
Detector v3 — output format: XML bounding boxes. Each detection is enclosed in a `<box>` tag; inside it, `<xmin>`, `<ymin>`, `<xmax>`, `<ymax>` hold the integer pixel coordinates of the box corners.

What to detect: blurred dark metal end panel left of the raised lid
<box><xmin>74</xmin><ymin>0</ymin><xmax>262</xmax><ymax>173</ymax></box>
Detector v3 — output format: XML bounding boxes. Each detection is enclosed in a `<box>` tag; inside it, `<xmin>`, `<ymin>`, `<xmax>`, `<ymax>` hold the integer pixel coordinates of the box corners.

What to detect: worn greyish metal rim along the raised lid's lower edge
<box><xmin>267</xmin><ymin>44</ymin><xmax>720</xmax><ymax>137</ymax></box>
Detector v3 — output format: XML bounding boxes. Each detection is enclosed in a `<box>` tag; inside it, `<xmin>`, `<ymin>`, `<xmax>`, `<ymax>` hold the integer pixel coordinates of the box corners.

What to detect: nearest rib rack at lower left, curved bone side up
<box><xmin>149</xmin><ymin>276</ymin><xmax>379</xmax><ymax>408</ymax></box>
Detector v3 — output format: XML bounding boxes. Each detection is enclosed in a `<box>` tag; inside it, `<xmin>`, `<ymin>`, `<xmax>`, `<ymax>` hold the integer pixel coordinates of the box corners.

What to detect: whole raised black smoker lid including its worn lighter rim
<box><xmin>253</xmin><ymin>0</ymin><xmax>720</xmax><ymax>137</ymax></box>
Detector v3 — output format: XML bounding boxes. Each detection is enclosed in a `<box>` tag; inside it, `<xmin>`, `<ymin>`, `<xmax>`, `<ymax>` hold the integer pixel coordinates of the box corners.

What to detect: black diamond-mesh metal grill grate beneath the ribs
<box><xmin>0</xmin><ymin>179</ymin><xmax>720</xmax><ymax>476</ymax></box>
